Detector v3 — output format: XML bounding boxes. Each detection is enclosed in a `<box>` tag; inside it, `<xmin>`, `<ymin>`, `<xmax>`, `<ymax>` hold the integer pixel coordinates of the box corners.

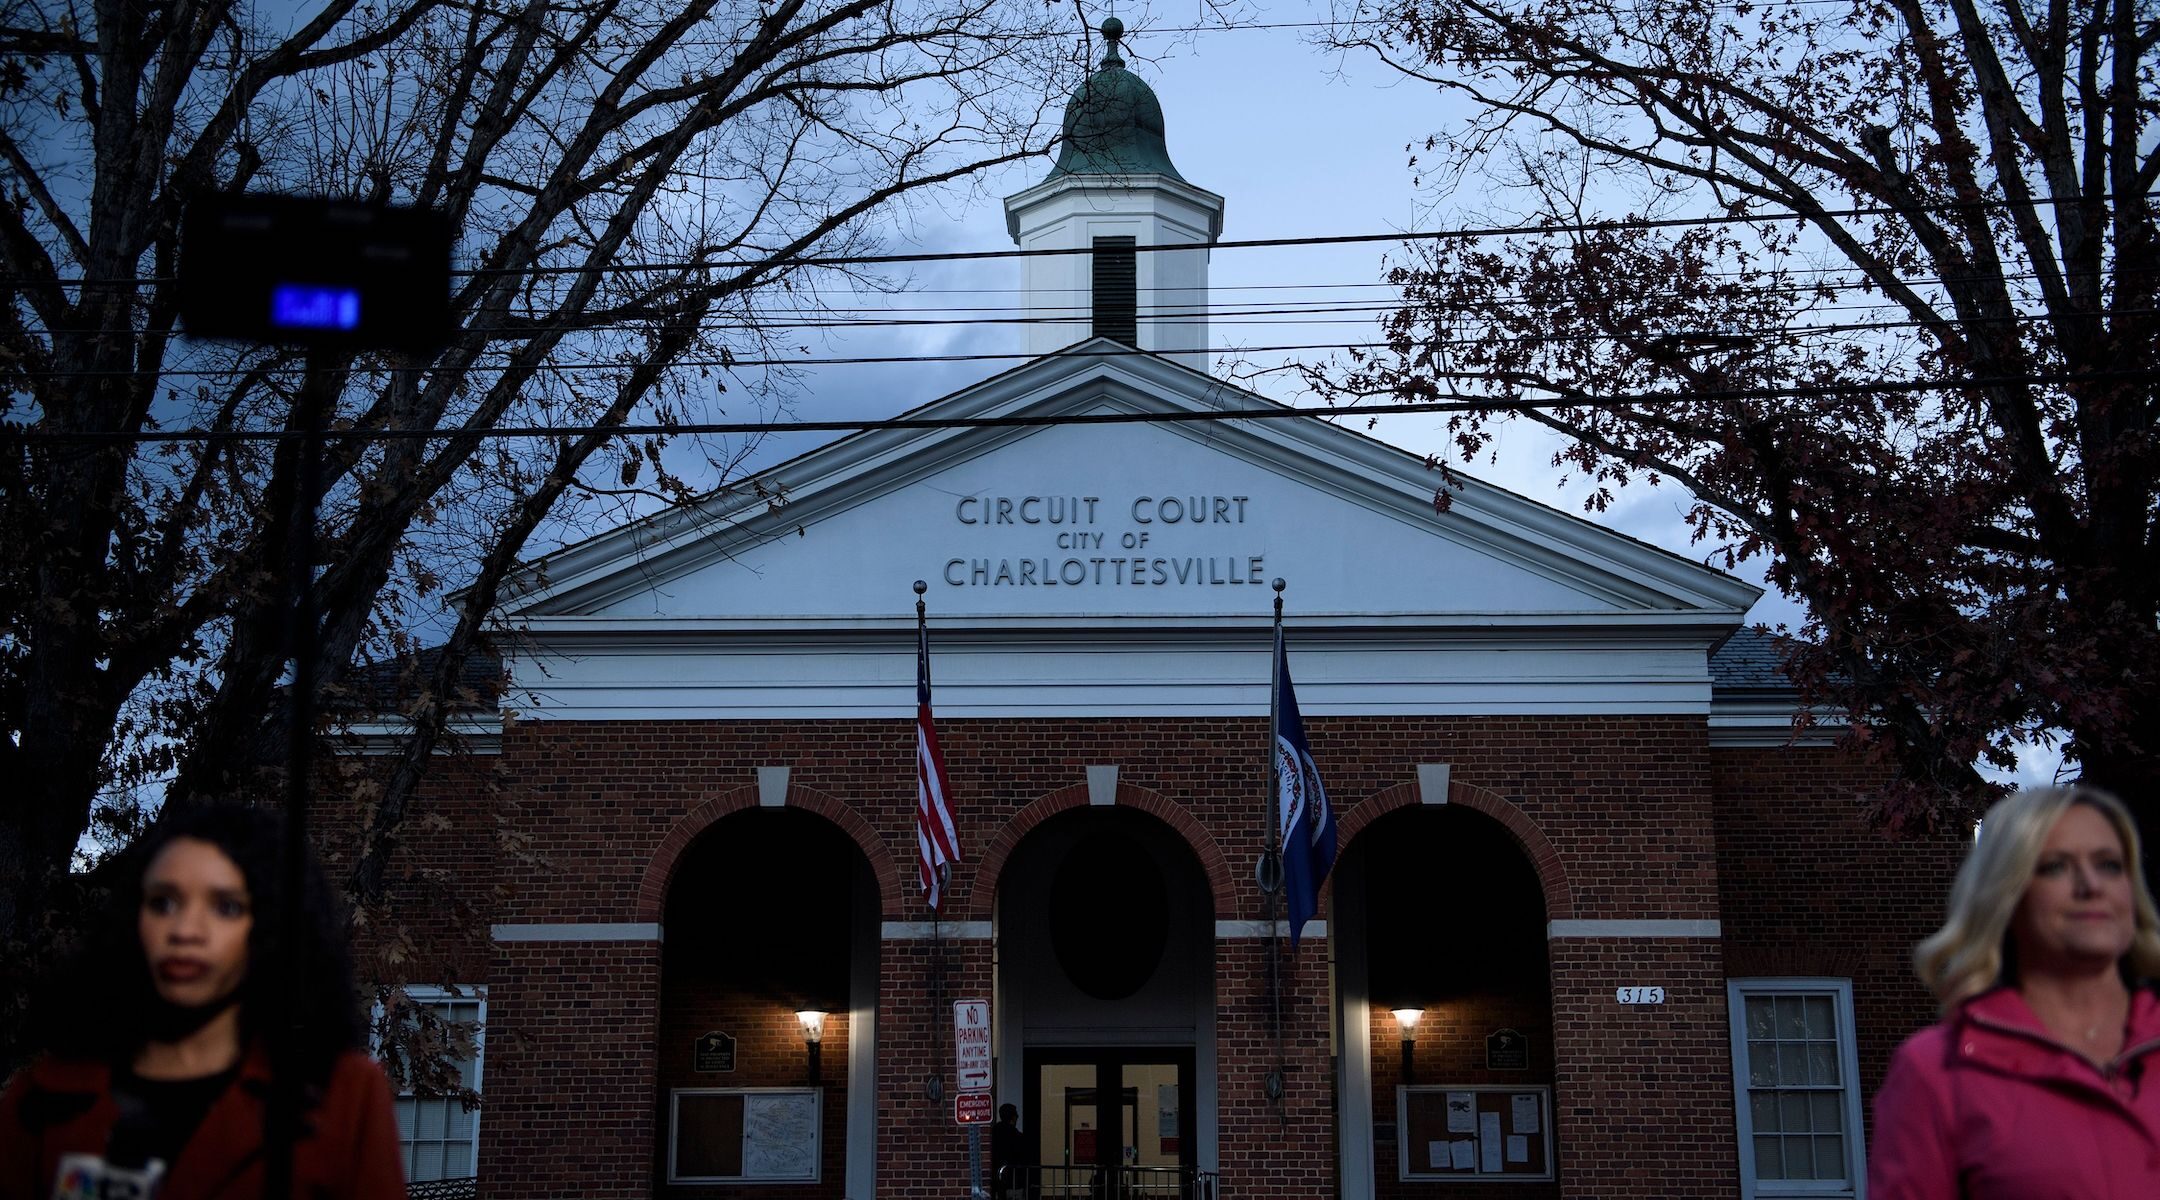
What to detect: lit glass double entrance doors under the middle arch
<box><xmin>1022</xmin><ymin>1047</ymin><xmax>1192</xmax><ymax>1200</ymax></box>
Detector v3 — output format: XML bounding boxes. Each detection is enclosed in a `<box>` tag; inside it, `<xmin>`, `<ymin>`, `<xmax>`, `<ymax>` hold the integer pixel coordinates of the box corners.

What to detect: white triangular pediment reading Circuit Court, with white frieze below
<box><xmin>499</xmin><ymin>341</ymin><xmax>1758</xmax><ymax>721</ymax></box>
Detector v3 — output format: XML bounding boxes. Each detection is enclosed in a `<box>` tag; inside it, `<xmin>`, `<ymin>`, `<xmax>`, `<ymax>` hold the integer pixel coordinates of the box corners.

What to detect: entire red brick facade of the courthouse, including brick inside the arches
<box><xmin>349</xmin><ymin>717</ymin><xmax>1961</xmax><ymax>1200</ymax></box>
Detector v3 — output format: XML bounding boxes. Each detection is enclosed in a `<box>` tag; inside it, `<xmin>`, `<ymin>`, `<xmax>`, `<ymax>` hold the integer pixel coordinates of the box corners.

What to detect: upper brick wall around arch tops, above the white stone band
<box><xmin>490</xmin><ymin>717</ymin><xmax>1717</xmax><ymax>922</ymax></box>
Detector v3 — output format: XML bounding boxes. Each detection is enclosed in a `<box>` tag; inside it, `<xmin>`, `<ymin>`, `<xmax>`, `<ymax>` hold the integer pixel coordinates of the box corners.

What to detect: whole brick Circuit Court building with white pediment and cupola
<box><xmin>362</xmin><ymin>25</ymin><xmax>1959</xmax><ymax>1200</ymax></box>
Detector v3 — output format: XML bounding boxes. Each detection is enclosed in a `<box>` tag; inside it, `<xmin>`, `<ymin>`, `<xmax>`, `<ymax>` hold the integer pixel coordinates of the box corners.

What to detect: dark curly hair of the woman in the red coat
<box><xmin>45</xmin><ymin>803</ymin><xmax>363</xmax><ymax>1083</ymax></box>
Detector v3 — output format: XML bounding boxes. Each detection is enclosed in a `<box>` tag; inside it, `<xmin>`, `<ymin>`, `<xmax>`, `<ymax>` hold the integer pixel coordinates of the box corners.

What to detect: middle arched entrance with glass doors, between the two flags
<box><xmin>996</xmin><ymin>805</ymin><xmax>1216</xmax><ymax>1198</ymax></box>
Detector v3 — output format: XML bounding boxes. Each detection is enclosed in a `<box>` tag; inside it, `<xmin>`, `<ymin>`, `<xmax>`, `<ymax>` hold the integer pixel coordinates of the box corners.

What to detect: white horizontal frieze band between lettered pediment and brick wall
<box><xmin>505</xmin><ymin>622</ymin><xmax>1717</xmax><ymax>721</ymax></box>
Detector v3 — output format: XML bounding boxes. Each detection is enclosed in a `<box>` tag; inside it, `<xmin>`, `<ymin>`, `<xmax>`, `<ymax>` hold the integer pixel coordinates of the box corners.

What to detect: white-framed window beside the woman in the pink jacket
<box><xmin>1726</xmin><ymin>978</ymin><xmax>1866</xmax><ymax>1200</ymax></box>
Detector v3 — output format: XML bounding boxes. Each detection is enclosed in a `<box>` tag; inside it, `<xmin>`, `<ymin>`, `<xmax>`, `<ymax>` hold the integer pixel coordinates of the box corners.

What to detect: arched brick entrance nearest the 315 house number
<box><xmin>1331</xmin><ymin>805</ymin><xmax>1560</xmax><ymax>1200</ymax></box>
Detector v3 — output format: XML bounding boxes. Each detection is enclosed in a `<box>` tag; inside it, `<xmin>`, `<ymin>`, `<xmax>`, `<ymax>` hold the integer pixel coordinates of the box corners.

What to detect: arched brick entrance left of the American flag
<box><xmin>654</xmin><ymin>807</ymin><xmax>879</xmax><ymax>1200</ymax></box>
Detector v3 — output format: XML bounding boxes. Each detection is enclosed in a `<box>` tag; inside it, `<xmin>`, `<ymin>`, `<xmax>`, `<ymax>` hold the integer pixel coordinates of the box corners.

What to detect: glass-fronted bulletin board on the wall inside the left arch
<box><xmin>667</xmin><ymin>1088</ymin><xmax>825</xmax><ymax>1183</ymax></box>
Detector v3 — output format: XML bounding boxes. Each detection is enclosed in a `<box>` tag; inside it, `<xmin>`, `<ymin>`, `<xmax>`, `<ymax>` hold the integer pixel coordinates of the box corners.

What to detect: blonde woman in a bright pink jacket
<box><xmin>1868</xmin><ymin>788</ymin><xmax>2160</xmax><ymax>1200</ymax></box>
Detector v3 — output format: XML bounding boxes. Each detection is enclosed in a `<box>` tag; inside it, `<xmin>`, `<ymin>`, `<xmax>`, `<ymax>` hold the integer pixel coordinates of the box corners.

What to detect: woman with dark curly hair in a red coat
<box><xmin>0</xmin><ymin>805</ymin><xmax>404</xmax><ymax>1200</ymax></box>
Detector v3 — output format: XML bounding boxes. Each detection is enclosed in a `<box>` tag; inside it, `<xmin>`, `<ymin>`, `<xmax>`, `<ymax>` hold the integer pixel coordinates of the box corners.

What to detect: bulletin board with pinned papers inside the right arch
<box><xmin>1395</xmin><ymin>1083</ymin><xmax>1553</xmax><ymax>1183</ymax></box>
